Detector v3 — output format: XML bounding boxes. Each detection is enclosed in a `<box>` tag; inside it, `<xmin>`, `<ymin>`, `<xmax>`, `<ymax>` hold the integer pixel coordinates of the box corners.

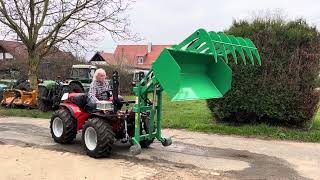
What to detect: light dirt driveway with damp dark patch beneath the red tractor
<box><xmin>0</xmin><ymin>117</ymin><xmax>320</xmax><ymax>180</ymax></box>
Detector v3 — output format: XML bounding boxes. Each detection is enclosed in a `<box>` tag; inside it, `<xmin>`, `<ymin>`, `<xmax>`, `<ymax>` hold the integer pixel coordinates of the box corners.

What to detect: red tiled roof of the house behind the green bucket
<box><xmin>114</xmin><ymin>45</ymin><xmax>171</xmax><ymax>68</ymax></box>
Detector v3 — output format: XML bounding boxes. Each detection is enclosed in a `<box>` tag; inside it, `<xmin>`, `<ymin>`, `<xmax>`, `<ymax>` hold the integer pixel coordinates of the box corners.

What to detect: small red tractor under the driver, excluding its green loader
<box><xmin>50</xmin><ymin>72</ymin><xmax>154</xmax><ymax>158</ymax></box>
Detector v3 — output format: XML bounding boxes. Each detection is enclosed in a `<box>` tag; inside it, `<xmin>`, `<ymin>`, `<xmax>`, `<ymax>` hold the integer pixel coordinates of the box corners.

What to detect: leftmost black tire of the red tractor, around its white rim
<box><xmin>50</xmin><ymin>108</ymin><xmax>77</xmax><ymax>144</ymax></box>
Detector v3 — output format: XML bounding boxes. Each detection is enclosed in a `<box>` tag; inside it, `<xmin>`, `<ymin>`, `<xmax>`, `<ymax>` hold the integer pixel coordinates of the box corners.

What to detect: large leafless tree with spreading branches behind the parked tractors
<box><xmin>0</xmin><ymin>0</ymin><xmax>132</xmax><ymax>89</ymax></box>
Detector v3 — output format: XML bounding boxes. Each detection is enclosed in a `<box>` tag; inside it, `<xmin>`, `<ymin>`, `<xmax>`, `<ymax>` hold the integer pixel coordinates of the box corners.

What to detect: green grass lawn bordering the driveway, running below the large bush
<box><xmin>0</xmin><ymin>93</ymin><xmax>320</xmax><ymax>142</ymax></box>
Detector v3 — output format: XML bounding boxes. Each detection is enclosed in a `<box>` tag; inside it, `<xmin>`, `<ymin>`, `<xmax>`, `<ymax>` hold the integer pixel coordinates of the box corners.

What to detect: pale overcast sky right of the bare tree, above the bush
<box><xmin>86</xmin><ymin>0</ymin><xmax>320</xmax><ymax>59</ymax></box>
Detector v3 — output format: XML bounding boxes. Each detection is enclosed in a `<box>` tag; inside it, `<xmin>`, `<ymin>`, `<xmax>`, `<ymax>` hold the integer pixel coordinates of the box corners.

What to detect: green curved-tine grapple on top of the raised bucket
<box><xmin>172</xmin><ymin>29</ymin><xmax>261</xmax><ymax>65</ymax></box>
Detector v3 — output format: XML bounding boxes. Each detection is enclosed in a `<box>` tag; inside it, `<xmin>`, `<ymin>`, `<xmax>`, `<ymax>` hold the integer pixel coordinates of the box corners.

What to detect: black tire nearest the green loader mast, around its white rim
<box><xmin>82</xmin><ymin>118</ymin><xmax>115</xmax><ymax>158</ymax></box>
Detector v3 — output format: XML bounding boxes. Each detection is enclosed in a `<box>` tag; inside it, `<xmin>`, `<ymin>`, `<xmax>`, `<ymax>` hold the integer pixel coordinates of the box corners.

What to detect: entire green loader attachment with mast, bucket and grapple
<box><xmin>130</xmin><ymin>29</ymin><xmax>261</xmax><ymax>154</ymax></box>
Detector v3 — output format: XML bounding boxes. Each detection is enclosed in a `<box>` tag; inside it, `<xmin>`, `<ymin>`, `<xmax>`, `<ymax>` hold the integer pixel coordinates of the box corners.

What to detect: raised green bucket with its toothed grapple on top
<box><xmin>152</xmin><ymin>29</ymin><xmax>261</xmax><ymax>101</ymax></box>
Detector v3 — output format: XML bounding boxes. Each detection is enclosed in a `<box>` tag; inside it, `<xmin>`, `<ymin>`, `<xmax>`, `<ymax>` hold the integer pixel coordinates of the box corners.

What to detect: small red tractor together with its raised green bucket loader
<box><xmin>50</xmin><ymin>29</ymin><xmax>261</xmax><ymax>158</ymax></box>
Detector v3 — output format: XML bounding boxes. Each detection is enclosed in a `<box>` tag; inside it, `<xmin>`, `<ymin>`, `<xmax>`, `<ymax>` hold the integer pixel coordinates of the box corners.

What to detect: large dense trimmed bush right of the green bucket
<box><xmin>207</xmin><ymin>18</ymin><xmax>320</xmax><ymax>126</ymax></box>
